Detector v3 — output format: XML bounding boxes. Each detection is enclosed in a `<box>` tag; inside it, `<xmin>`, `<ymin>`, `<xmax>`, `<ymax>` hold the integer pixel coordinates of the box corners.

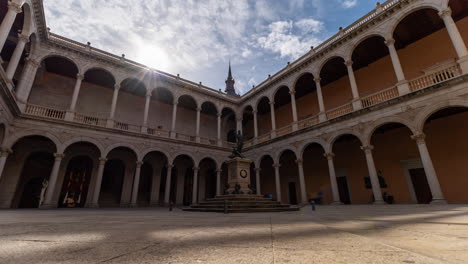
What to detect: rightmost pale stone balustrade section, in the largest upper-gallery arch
<box><xmin>409</xmin><ymin>64</ymin><xmax>462</xmax><ymax>92</ymax></box>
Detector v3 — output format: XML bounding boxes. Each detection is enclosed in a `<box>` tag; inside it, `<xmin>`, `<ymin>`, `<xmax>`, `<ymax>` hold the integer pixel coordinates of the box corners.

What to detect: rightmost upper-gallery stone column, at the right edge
<box><xmin>439</xmin><ymin>7</ymin><xmax>468</xmax><ymax>74</ymax></box>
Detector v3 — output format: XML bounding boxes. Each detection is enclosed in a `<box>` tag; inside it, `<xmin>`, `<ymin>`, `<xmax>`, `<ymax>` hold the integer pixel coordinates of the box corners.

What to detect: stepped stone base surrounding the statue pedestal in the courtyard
<box><xmin>183</xmin><ymin>194</ymin><xmax>299</xmax><ymax>213</ymax></box>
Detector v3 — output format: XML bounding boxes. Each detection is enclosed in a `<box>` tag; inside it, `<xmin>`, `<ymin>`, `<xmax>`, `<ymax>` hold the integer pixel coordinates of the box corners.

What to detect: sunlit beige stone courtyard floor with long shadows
<box><xmin>0</xmin><ymin>205</ymin><xmax>468</xmax><ymax>264</ymax></box>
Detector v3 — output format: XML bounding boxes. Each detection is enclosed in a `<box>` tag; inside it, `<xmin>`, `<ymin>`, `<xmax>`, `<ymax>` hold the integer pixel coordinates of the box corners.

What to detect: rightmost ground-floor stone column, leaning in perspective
<box><xmin>411</xmin><ymin>133</ymin><xmax>447</xmax><ymax>203</ymax></box>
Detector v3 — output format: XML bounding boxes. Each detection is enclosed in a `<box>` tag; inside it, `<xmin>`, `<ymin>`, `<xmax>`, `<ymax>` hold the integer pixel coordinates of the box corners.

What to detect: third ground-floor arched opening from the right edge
<box><xmin>333</xmin><ymin>134</ymin><xmax>374</xmax><ymax>204</ymax></box>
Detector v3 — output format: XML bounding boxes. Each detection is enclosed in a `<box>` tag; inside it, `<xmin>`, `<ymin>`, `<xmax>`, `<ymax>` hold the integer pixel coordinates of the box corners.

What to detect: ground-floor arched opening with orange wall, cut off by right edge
<box><xmin>424</xmin><ymin>107</ymin><xmax>468</xmax><ymax>203</ymax></box>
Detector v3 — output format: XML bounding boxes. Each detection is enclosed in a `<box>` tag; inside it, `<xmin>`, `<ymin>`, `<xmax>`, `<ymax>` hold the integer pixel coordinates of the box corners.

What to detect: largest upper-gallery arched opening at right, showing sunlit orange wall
<box><xmin>393</xmin><ymin>8</ymin><xmax>457</xmax><ymax>80</ymax></box>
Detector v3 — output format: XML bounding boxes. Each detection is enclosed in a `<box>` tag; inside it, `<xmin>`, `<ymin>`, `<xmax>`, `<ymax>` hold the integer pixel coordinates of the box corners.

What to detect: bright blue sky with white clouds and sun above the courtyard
<box><xmin>44</xmin><ymin>0</ymin><xmax>377</xmax><ymax>94</ymax></box>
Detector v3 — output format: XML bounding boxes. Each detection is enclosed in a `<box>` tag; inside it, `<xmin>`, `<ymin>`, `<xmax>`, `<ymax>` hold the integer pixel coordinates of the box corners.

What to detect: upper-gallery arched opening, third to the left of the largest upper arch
<box><xmin>294</xmin><ymin>73</ymin><xmax>320</xmax><ymax>124</ymax></box>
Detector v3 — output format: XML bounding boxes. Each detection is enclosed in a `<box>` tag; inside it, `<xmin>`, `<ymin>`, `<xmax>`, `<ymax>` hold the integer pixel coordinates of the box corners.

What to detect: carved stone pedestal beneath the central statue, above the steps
<box><xmin>227</xmin><ymin>157</ymin><xmax>252</xmax><ymax>194</ymax></box>
